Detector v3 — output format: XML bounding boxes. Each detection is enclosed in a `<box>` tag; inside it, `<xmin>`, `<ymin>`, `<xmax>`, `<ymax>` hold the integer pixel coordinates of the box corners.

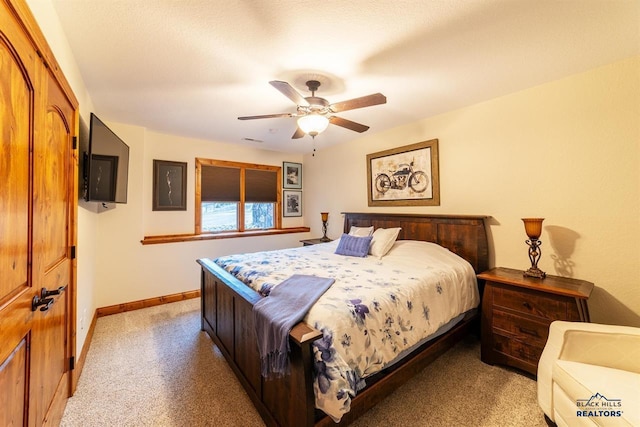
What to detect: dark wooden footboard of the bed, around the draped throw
<box><xmin>198</xmin><ymin>259</ymin><xmax>322</xmax><ymax>426</ymax></box>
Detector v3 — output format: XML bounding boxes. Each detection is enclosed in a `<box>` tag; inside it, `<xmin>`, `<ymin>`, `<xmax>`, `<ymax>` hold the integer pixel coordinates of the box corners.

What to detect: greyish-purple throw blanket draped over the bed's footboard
<box><xmin>253</xmin><ymin>274</ymin><xmax>334</xmax><ymax>378</ymax></box>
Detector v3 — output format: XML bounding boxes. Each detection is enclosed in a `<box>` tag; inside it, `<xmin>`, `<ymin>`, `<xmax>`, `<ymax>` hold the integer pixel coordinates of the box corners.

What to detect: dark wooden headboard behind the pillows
<box><xmin>343</xmin><ymin>212</ymin><xmax>489</xmax><ymax>273</ymax></box>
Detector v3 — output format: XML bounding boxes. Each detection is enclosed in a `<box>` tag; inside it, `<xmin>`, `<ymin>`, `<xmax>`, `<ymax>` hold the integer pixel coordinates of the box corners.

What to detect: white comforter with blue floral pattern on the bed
<box><xmin>214</xmin><ymin>240</ymin><xmax>479</xmax><ymax>422</ymax></box>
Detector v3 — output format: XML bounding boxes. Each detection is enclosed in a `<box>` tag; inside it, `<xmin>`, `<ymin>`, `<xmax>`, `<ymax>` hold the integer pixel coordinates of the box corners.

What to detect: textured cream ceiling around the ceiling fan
<box><xmin>52</xmin><ymin>0</ymin><xmax>640</xmax><ymax>152</ymax></box>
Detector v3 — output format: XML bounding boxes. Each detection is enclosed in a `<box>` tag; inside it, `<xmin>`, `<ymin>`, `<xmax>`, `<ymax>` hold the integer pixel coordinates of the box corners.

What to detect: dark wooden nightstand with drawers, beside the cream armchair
<box><xmin>478</xmin><ymin>268</ymin><xmax>593</xmax><ymax>376</ymax></box>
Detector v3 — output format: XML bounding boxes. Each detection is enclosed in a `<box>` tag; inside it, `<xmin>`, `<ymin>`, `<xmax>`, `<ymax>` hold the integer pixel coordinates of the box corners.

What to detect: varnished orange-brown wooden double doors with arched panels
<box><xmin>0</xmin><ymin>1</ymin><xmax>77</xmax><ymax>426</ymax></box>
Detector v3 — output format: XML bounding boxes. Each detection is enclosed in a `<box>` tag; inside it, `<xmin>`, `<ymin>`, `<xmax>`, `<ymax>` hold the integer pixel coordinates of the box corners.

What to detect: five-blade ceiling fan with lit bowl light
<box><xmin>238</xmin><ymin>80</ymin><xmax>387</xmax><ymax>139</ymax></box>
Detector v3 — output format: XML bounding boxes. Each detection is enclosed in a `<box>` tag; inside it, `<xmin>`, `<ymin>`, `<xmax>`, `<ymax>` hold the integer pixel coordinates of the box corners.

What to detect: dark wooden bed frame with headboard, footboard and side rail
<box><xmin>198</xmin><ymin>213</ymin><xmax>488</xmax><ymax>426</ymax></box>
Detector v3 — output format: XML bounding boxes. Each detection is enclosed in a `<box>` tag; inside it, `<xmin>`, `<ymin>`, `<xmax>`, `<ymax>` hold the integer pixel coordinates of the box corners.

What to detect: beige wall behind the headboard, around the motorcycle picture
<box><xmin>304</xmin><ymin>57</ymin><xmax>640</xmax><ymax>326</ymax></box>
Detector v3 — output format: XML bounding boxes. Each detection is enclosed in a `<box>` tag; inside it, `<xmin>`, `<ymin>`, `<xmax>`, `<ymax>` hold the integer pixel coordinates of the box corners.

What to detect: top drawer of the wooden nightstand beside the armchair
<box><xmin>493</xmin><ymin>287</ymin><xmax>567</xmax><ymax>320</ymax></box>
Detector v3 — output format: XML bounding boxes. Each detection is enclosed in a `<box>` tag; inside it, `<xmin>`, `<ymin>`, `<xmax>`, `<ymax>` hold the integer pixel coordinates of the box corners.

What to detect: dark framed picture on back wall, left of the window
<box><xmin>153</xmin><ymin>160</ymin><xmax>187</xmax><ymax>211</ymax></box>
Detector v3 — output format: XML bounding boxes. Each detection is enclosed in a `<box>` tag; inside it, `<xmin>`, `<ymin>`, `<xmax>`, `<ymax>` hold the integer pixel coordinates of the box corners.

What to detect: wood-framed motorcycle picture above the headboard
<box><xmin>367</xmin><ymin>139</ymin><xmax>440</xmax><ymax>206</ymax></box>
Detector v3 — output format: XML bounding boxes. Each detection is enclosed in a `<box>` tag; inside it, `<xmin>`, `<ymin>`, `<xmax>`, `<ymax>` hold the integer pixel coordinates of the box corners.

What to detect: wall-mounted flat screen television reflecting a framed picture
<box><xmin>84</xmin><ymin>113</ymin><xmax>129</xmax><ymax>203</ymax></box>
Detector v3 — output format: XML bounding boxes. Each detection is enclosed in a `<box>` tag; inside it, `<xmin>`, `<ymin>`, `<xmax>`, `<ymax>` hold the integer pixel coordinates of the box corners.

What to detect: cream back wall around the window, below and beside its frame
<box><xmin>95</xmin><ymin>122</ymin><xmax>309</xmax><ymax>307</ymax></box>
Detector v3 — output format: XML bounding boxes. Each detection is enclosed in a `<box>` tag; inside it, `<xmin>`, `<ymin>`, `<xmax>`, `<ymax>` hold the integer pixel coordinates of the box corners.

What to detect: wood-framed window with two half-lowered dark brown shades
<box><xmin>196</xmin><ymin>159</ymin><xmax>282</xmax><ymax>234</ymax></box>
